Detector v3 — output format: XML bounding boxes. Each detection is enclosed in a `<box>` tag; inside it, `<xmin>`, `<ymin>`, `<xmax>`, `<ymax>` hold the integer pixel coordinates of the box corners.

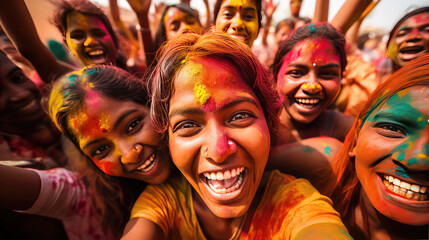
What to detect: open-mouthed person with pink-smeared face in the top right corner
<box><xmin>386</xmin><ymin>7</ymin><xmax>429</xmax><ymax>71</ymax></box>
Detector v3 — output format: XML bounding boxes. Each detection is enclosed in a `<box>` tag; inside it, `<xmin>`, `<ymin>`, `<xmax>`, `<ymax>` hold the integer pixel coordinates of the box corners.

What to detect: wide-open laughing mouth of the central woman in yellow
<box><xmin>202</xmin><ymin>167</ymin><xmax>246</xmax><ymax>194</ymax></box>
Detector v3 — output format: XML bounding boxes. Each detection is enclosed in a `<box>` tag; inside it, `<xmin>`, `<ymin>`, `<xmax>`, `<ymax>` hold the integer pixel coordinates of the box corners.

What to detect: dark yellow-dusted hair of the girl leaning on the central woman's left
<box><xmin>49</xmin><ymin>65</ymin><xmax>148</xmax><ymax>235</ymax></box>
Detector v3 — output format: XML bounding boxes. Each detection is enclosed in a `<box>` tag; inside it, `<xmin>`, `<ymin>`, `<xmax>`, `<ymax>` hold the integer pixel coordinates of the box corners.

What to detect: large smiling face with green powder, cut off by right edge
<box><xmin>355</xmin><ymin>86</ymin><xmax>429</xmax><ymax>225</ymax></box>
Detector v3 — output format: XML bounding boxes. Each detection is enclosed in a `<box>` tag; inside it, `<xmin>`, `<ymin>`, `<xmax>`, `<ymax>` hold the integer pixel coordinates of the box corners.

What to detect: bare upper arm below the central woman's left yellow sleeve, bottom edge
<box><xmin>121</xmin><ymin>218</ymin><xmax>165</xmax><ymax>240</ymax></box>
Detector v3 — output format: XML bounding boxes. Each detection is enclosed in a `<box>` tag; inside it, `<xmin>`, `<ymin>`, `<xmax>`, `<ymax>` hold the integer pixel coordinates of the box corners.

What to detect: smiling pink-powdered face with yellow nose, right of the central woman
<box><xmin>276</xmin><ymin>37</ymin><xmax>341</xmax><ymax>123</ymax></box>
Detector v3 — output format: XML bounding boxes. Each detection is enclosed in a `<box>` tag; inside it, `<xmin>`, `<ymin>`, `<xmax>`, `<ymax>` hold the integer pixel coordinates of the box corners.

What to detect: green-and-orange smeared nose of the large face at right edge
<box><xmin>392</xmin><ymin>125</ymin><xmax>429</xmax><ymax>171</ymax></box>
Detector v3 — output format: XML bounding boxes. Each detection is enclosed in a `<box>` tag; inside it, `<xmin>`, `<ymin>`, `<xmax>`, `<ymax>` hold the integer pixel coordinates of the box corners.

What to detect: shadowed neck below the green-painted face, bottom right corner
<box><xmin>356</xmin><ymin>190</ymin><xmax>429</xmax><ymax>240</ymax></box>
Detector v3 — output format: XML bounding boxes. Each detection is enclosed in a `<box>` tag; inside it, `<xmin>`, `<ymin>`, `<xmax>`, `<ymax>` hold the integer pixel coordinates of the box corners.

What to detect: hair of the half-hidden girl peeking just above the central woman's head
<box><xmin>155</xmin><ymin>3</ymin><xmax>201</xmax><ymax>50</ymax></box>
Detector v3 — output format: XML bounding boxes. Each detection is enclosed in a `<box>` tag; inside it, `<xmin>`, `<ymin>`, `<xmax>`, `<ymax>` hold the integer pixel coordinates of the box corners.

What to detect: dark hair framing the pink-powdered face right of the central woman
<box><xmin>271</xmin><ymin>23</ymin><xmax>347</xmax><ymax>82</ymax></box>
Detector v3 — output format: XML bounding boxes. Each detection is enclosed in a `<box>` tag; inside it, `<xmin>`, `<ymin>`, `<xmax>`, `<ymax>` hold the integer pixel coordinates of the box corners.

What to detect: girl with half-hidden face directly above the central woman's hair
<box><xmin>155</xmin><ymin>3</ymin><xmax>202</xmax><ymax>52</ymax></box>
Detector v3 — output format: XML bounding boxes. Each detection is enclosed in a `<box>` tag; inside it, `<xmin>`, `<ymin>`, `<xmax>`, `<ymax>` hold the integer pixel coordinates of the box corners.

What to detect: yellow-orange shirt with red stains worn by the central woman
<box><xmin>131</xmin><ymin>170</ymin><xmax>351</xmax><ymax>239</ymax></box>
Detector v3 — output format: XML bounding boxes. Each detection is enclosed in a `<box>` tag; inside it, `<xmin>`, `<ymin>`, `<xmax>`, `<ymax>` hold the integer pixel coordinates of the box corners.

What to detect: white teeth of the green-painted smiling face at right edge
<box><xmin>383</xmin><ymin>175</ymin><xmax>428</xmax><ymax>201</ymax></box>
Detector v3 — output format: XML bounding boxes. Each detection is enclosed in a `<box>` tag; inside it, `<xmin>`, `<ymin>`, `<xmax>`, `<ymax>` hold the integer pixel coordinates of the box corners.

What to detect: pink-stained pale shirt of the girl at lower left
<box><xmin>20</xmin><ymin>168</ymin><xmax>118</xmax><ymax>240</ymax></box>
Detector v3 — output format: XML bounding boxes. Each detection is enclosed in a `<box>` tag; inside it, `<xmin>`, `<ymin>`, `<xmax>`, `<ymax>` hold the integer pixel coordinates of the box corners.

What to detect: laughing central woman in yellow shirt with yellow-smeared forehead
<box><xmin>123</xmin><ymin>33</ymin><xmax>348</xmax><ymax>239</ymax></box>
